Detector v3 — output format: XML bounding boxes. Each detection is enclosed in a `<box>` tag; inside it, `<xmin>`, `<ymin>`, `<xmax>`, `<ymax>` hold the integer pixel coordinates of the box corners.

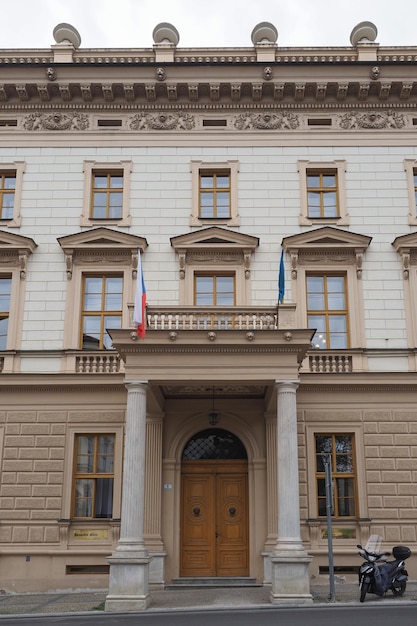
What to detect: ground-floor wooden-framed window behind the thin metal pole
<box><xmin>315</xmin><ymin>434</ymin><xmax>357</xmax><ymax>517</ymax></box>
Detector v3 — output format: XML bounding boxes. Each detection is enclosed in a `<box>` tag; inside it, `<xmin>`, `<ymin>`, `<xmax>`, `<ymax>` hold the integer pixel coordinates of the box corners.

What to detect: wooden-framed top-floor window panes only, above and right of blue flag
<box><xmin>307</xmin><ymin>170</ymin><xmax>339</xmax><ymax>219</ymax></box>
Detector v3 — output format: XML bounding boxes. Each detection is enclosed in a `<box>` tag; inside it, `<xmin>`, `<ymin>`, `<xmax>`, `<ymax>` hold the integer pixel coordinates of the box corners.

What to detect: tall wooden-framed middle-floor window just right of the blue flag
<box><xmin>306</xmin><ymin>274</ymin><xmax>349</xmax><ymax>350</ymax></box>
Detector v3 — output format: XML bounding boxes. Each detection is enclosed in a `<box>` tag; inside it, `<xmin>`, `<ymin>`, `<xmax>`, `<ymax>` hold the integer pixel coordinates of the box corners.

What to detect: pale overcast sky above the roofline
<box><xmin>0</xmin><ymin>0</ymin><xmax>417</xmax><ymax>50</ymax></box>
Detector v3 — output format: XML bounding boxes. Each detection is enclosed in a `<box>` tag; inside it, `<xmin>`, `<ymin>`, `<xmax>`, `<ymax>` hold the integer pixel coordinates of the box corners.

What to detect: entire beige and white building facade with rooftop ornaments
<box><xmin>0</xmin><ymin>22</ymin><xmax>417</xmax><ymax>610</ymax></box>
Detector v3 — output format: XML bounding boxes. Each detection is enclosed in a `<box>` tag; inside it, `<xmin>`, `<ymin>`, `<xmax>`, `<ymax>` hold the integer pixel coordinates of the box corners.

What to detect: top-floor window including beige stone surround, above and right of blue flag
<box><xmin>298</xmin><ymin>160</ymin><xmax>349</xmax><ymax>226</ymax></box>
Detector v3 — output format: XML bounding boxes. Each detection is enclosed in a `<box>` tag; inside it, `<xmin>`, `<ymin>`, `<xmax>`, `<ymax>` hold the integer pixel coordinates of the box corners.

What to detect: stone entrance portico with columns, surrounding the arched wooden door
<box><xmin>106</xmin><ymin>308</ymin><xmax>312</xmax><ymax>611</ymax></box>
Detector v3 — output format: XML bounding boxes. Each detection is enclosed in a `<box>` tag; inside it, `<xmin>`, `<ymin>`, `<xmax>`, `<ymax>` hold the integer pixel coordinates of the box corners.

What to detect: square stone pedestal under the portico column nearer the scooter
<box><xmin>269</xmin><ymin>552</ymin><xmax>313</xmax><ymax>604</ymax></box>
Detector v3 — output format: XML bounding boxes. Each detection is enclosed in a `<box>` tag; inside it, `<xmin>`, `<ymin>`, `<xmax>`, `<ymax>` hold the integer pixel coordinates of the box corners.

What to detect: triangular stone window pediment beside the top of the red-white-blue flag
<box><xmin>58</xmin><ymin>227</ymin><xmax>148</xmax><ymax>280</ymax></box>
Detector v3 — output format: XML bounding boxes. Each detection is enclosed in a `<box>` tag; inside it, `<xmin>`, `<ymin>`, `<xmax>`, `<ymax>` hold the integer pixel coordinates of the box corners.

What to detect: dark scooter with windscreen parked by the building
<box><xmin>357</xmin><ymin>535</ymin><xmax>411</xmax><ymax>602</ymax></box>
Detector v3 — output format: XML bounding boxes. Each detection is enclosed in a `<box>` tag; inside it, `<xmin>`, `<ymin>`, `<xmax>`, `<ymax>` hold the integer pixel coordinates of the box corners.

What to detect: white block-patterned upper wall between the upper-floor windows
<box><xmin>0</xmin><ymin>146</ymin><xmax>417</xmax><ymax>350</ymax></box>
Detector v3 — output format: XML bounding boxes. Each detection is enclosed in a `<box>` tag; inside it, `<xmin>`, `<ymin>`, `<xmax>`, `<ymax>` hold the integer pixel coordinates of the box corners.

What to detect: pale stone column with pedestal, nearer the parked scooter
<box><xmin>271</xmin><ymin>381</ymin><xmax>312</xmax><ymax>604</ymax></box>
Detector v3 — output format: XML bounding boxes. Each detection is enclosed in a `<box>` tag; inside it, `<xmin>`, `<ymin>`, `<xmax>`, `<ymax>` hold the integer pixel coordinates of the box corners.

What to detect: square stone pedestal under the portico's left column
<box><xmin>105</xmin><ymin>556</ymin><xmax>150</xmax><ymax>611</ymax></box>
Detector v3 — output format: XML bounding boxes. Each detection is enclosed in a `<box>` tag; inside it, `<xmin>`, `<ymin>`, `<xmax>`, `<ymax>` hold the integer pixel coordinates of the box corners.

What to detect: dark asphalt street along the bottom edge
<box><xmin>0</xmin><ymin>603</ymin><xmax>417</xmax><ymax>626</ymax></box>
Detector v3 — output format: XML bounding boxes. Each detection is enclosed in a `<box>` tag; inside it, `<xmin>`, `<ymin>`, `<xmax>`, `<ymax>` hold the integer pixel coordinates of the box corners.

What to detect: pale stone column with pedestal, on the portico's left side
<box><xmin>106</xmin><ymin>380</ymin><xmax>150</xmax><ymax>611</ymax></box>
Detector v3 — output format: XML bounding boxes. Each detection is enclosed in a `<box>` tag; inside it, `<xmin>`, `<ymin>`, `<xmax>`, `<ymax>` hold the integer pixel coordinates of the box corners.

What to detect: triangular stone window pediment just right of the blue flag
<box><xmin>282</xmin><ymin>226</ymin><xmax>372</xmax><ymax>278</ymax></box>
